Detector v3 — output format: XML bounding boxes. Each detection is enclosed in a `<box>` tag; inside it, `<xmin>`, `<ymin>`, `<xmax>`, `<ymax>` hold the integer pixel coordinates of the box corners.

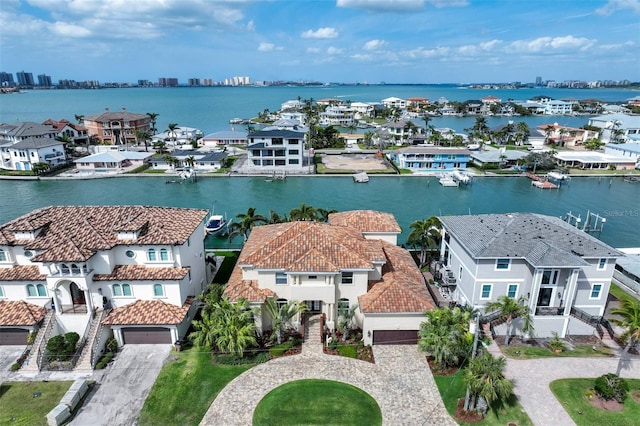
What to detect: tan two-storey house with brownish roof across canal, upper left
<box><xmin>84</xmin><ymin>108</ymin><xmax>151</xmax><ymax>145</ymax></box>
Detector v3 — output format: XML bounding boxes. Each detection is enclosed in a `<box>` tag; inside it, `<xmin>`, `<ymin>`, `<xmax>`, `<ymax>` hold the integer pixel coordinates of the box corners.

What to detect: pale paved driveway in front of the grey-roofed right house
<box><xmin>488</xmin><ymin>342</ymin><xmax>640</xmax><ymax>426</ymax></box>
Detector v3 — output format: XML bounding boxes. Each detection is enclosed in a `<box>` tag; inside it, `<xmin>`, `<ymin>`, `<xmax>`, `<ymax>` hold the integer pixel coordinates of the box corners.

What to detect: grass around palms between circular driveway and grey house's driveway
<box><xmin>433</xmin><ymin>370</ymin><xmax>533</xmax><ymax>426</ymax></box>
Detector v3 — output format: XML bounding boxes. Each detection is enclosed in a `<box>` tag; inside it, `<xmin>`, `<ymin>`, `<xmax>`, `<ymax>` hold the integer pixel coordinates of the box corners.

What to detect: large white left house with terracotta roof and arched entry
<box><xmin>0</xmin><ymin>206</ymin><xmax>212</xmax><ymax>356</ymax></box>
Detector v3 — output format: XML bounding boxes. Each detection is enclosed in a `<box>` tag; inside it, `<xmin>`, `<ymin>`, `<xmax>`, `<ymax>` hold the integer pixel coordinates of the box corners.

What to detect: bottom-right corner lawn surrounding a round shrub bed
<box><xmin>550</xmin><ymin>377</ymin><xmax>640</xmax><ymax>426</ymax></box>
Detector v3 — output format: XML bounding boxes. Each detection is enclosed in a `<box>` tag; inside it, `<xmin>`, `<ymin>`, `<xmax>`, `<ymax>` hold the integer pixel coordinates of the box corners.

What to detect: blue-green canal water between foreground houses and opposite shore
<box><xmin>0</xmin><ymin>176</ymin><xmax>640</xmax><ymax>248</ymax></box>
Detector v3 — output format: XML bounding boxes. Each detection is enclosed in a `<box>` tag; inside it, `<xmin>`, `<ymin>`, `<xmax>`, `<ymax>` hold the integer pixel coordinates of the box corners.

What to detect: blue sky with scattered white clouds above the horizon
<box><xmin>0</xmin><ymin>0</ymin><xmax>640</xmax><ymax>83</ymax></box>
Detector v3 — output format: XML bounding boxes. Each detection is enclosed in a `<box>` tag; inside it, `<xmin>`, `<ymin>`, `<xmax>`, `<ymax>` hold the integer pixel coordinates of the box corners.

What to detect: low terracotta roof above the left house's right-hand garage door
<box><xmin>102</xmin><ymin>298</ymin><xmax>193</xmax><ymax>325</ymax></box>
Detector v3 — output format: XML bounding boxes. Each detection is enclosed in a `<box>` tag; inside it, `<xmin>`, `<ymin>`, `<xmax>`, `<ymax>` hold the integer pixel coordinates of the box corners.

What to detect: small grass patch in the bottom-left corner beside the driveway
<box><xmin>0</xmin><ymin>381</ymin><xmax>73</xmax><ymax>426</ymax></box>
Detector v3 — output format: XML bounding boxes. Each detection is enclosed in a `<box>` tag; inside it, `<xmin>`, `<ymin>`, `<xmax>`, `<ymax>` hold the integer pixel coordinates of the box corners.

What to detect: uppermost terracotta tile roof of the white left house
<box><xmin>0</xmin><ymin>206</ymin><xmax>208</xmax><ymax>262</ymax></box>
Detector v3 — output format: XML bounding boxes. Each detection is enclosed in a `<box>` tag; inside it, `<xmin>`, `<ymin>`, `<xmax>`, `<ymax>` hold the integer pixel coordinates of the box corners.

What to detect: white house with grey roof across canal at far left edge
<box><xmin>0</xmin><ymin>122</ymin><xmax>67</xmax><ymax>170</ymax></box>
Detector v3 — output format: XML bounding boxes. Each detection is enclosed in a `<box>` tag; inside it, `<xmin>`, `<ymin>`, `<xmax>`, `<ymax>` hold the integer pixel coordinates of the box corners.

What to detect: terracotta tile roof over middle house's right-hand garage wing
<box><xmin>358</xmin><ymin>241</ymin><xmax>436</xmax><ymax>313</ymax></box>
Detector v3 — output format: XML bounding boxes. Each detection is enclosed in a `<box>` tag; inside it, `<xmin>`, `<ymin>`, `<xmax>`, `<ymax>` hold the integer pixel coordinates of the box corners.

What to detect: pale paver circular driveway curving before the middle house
<box><xmin>200</xmin><ymin>346</ymin><xmax>456</xmax><ymax>426</ymax></box>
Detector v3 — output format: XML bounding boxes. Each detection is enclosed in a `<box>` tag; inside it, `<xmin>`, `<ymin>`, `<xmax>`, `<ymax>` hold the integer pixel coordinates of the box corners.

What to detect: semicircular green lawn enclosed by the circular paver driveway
<box><xmin>253</xmin><ymin>379</ymin><xmax>382</xmax><ymax>426</ymax></box>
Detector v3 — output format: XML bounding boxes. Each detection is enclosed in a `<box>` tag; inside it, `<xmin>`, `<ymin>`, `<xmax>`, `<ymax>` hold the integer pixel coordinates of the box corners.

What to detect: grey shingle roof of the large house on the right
<box><xmin>439</xmin><ymin>213</ymin><xmax>622</xmax><ymax>267</ymax></box>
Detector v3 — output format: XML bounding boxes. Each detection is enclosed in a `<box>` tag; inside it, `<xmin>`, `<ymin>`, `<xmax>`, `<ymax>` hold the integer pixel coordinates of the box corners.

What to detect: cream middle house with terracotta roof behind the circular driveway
<box><xmin>224</xmin><ymin>210</ymin><xmax>435</xmax><ymax>344</ymax></box>
